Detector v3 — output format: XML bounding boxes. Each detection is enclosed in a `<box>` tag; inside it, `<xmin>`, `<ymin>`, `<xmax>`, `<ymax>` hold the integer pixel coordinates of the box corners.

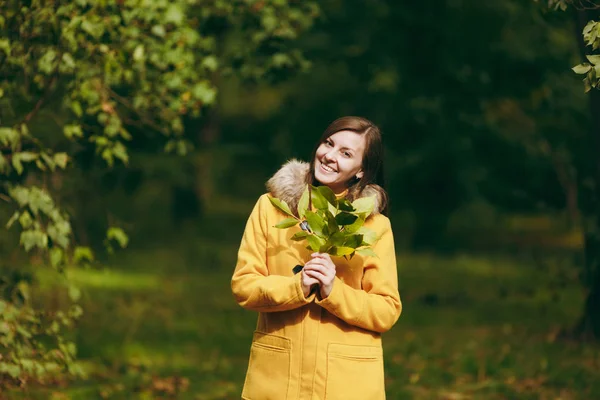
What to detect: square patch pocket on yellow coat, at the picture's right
<box><xmin>325</xmin><ymin>343</ymin><xmax>385</xmax><ymax>400</ymax></box>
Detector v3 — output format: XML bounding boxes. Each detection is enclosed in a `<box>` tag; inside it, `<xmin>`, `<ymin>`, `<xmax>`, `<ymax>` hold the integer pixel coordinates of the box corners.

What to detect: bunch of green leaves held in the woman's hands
<box><xmin>269</xmin><ymin>185</ymin><xmax>377</xmax><ymax>259</ymax></box>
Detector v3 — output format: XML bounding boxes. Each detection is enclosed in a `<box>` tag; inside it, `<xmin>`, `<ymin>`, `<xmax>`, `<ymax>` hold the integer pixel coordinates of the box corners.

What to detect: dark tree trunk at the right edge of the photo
<box><xmin>576</xmin><ymin>10</ymin><xmax>600</xmax><ymax>339</ymax></box>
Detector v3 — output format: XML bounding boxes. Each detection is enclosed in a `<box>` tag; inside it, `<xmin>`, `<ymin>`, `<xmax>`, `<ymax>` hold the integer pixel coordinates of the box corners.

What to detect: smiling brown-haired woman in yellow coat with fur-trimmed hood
<box><xmin>231</xmin><ymin>117</ymin><xmax>402</xmax><ymax>400</ymax></box>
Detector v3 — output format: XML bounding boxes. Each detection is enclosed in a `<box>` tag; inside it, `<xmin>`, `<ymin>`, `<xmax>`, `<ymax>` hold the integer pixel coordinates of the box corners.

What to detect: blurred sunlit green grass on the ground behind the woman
<box><xmin>14</xmin><ymin>243</ymin><xmax>600</xmax><ymax>400</ymax></box>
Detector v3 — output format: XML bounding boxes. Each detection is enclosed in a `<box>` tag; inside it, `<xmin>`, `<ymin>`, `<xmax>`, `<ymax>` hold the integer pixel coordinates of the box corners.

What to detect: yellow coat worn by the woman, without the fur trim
<box><xmin>231</xmin><ymin>160</ymin><xmax>402</xmax><ymax>400</ymax></box>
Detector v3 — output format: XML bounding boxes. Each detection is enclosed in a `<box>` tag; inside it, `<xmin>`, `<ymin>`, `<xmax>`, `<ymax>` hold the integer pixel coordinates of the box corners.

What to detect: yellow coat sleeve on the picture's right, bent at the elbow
<box><xmin>315</xmin><ymin>216</ymin><xmax>402</xmax><ymax>333</ymax></box>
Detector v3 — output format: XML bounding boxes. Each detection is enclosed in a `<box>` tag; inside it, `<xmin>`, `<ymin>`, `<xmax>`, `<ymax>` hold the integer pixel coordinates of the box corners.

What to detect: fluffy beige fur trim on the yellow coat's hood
<box><xmin>266</xmin><ymin>159</ymin><xmax>382</xmax><ymax>215</ymax></box>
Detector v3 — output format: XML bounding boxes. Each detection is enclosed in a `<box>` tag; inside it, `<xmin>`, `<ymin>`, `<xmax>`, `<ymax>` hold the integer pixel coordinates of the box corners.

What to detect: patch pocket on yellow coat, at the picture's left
<box><xmin>242</xmin><ymin>331</ymin><xmax>292</xmax><ymax>400</ymax></box>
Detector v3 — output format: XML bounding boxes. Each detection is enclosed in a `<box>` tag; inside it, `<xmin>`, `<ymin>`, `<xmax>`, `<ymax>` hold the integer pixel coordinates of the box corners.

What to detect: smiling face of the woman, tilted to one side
<box><xmin>314</xmin><ymin>131</ymin><xmax>366</xmax><ymax>194</ymax></box>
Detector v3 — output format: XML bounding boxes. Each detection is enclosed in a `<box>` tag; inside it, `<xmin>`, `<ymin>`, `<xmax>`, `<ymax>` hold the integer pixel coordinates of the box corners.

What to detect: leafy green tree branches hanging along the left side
<box><xmin>0</xmin><ymin>0</ymin><xmax>318</xmax><ymax>385</ymax></box>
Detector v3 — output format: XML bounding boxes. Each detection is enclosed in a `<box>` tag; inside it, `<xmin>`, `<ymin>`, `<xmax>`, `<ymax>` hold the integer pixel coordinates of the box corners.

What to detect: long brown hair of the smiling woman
<box><xmin>307</xmin><ymin>116</ymin><xmax>388</xmax><ymax>215</ymax></box>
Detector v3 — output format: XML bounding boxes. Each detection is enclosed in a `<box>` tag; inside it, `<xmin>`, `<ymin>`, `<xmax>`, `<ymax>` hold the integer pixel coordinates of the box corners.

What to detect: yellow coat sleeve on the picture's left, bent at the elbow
<box><xmin>231</xmin><ymin>194</ymin><xmax>315</xmax><ymax>312</ymax></box>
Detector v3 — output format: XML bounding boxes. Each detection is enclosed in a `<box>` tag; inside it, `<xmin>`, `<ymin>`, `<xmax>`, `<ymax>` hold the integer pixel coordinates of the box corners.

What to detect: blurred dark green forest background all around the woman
<box><xmin>0</xmin><ymin>0</ymin><xmax>600</xmax><ymax>400</ymax></box>
